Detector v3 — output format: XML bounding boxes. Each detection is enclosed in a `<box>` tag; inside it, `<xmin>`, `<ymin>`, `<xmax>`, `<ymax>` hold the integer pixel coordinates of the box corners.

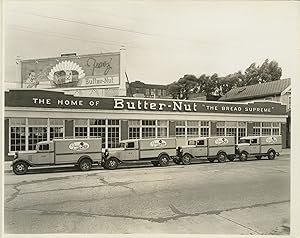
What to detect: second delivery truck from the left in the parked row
<box><xmin>102</xmin><ymin>138</ymin><xmax>176</xmax><ymax>169</ymax></box>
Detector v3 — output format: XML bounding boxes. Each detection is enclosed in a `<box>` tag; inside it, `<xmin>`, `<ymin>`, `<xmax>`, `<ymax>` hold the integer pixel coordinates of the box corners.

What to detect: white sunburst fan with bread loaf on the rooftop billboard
<box><xmin>48</xmin><ymin>60</ymin><xmax>85</xmax><ymax>87</ymax></box>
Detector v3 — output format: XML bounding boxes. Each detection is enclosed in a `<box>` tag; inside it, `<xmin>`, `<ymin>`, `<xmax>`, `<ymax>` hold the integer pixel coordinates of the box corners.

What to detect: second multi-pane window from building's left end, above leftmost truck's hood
<box><xmin>28</xmin><ymin>118</ymin><xmax>48</xmax><ymax>150</ymax></box>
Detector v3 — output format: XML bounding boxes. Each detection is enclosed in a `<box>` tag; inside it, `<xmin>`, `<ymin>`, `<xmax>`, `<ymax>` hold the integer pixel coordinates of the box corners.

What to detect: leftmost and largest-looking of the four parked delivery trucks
<box><xmin>12</xmin><ymin>138</ymin><xmax>102</xmax><ymax>175</ymax></box>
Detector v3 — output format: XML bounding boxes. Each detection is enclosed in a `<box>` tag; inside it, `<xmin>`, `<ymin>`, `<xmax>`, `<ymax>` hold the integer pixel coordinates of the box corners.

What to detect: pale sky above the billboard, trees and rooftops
<box><xmin>3</xmin><ymin>0</ymin><xmax>300</xmax><ymax>84</ymax></box>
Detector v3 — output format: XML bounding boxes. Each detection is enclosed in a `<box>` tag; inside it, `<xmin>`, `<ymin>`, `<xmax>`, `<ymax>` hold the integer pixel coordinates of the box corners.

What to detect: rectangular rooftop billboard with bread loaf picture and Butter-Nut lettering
<box><xmin>21</xmin><ymin>53</ymin><xmax>120</xmax><ymax>88</ymax></box>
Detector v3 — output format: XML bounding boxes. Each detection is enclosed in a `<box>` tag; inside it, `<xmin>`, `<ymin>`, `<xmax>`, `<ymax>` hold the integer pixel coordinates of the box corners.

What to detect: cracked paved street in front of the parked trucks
<box><xmin>5</xmin><ymin>154</ymin><xmax>290</xmax><ymax>235</ymax></box>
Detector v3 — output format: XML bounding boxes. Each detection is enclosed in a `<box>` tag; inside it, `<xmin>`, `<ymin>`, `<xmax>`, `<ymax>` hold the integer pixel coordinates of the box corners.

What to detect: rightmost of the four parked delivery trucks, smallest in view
<box><xmin>237</xmin><ymin>135</ymin><xmax>282</xmax><ymax>161</ymax></box>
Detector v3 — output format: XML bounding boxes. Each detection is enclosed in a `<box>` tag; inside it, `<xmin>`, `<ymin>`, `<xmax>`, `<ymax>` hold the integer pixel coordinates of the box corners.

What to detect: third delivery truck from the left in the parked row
<box><xmin>174</xmin><ymin>136</ymin><xmax>235</xmax><ymax>164</ymax></box>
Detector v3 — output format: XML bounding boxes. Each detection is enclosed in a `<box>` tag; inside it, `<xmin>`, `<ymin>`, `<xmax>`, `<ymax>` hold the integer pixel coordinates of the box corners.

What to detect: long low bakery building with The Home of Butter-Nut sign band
<box><xmin>5</xmin><ymin>89</ymin><xmax>287</xmax><ymax>159</ymax></box>
